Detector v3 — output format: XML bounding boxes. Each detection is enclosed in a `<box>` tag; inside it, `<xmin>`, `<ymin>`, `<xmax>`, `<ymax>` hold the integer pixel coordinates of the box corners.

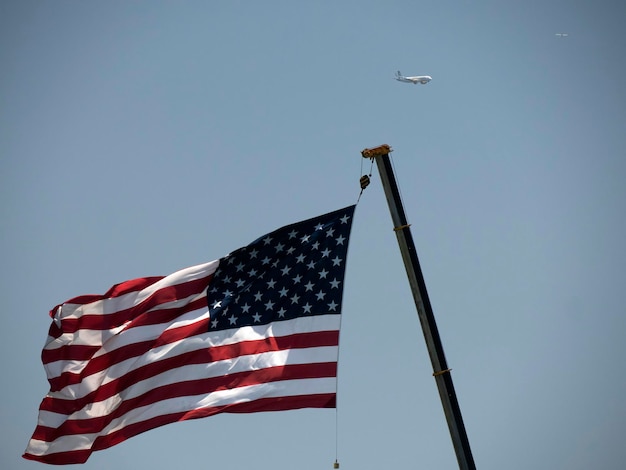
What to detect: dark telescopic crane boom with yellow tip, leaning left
<box><xmin>361</xmin><ymin>145</ymin><xmax>476</xmax><ymax>470</ymax></box>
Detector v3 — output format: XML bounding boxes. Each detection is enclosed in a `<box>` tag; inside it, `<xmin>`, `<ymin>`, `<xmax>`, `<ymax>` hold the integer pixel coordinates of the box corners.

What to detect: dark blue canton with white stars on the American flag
<box><xmin>207</xmin><ymin>206</ymin><xmax>355</xmax><ymax>330</ymax></box>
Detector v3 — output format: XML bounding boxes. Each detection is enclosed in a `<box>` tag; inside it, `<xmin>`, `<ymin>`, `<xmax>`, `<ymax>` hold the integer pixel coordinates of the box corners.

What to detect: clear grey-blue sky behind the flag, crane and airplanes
<box><xmin>0</xmin><ymin>0</ymin><xmax>626</xmax><ymax>470</ymax></box>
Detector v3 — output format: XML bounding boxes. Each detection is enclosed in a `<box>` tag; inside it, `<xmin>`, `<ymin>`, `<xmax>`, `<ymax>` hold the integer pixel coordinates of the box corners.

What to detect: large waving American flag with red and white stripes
<box><xmin>24</xmin><ymin>206</ymin><xmax>355</xmax><ymax>464</ymax></box>
